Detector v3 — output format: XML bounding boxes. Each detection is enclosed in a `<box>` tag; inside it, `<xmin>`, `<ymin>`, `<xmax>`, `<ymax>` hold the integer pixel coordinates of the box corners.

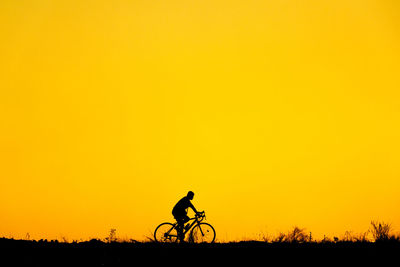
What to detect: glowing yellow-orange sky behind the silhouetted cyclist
<box><xmin>0</xmin><ymin>0</ymin><xmax>400</xmax><ymax>240</ymax></box>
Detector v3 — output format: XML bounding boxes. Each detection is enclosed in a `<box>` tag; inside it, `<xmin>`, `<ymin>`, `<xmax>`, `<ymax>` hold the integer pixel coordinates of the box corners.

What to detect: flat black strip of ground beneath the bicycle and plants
<box><xmin>0</xmin><ymin>238</ymin><xmax>400</xmax><ymax>266</ymax></box>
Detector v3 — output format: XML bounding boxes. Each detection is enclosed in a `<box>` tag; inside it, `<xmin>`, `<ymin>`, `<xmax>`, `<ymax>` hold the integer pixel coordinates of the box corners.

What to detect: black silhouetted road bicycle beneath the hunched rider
<box><xmin>154</xmin><ymin>211</ymin><xmax>216</xmax><ymax>243</ymax></box>
